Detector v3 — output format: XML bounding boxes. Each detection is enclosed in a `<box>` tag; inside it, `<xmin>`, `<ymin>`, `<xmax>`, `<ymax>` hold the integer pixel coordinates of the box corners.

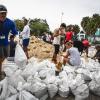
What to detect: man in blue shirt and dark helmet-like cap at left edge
<box><xmin>0</xmin><ymin>4</ymin><xmax>18</xmax><ymax>80</ymax></box>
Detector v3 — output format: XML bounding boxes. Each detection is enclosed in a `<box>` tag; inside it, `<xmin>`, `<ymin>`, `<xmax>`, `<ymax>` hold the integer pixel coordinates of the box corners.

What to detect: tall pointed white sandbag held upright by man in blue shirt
<box><xmin>14</xmin><ymin>44</ymin><xmax>27</xmax><ymax>69</ymax></box>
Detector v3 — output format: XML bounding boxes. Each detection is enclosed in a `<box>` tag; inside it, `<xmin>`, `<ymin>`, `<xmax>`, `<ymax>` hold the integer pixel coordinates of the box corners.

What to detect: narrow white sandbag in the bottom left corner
<box><xmin>0</xmin><ymin>77</ymin><xmax>8</xmax><ymax>100</ymax></box>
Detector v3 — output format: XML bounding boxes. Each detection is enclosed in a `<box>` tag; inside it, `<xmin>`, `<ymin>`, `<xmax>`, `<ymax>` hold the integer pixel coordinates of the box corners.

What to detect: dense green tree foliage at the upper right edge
<box><xmin>81</xmin><ymin>14</ymin><xmax>100</xmax><ymax>35</ymax></box>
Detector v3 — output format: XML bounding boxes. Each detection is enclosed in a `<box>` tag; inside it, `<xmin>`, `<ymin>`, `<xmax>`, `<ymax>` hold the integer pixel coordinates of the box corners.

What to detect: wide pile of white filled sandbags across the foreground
<box><xmin>0</xmin><ymin>46</ymin><xmax>100</xmax><ymax>100</ymax></box>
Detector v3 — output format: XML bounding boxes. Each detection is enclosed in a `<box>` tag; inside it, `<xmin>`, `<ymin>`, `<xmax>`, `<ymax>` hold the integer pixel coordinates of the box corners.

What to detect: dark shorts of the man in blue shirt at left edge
<box><xmin>0</xmin><ymin>45</ymin><xmax>10</xmax><ymax>58</ymax></box>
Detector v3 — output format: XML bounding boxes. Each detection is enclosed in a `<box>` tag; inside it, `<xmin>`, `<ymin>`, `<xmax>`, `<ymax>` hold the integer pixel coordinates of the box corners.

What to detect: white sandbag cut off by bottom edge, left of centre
<box><xmin>19</xmin><ymin>90</ymin><xmax>39</xmax><ymax>100</ymax></box>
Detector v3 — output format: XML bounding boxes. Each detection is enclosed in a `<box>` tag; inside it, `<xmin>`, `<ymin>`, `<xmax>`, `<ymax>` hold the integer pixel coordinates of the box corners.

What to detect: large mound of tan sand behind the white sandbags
<box><xmin>28</xmin><ymin>36</ymin><xmax>54</xmax><ymax>59</ymax></box>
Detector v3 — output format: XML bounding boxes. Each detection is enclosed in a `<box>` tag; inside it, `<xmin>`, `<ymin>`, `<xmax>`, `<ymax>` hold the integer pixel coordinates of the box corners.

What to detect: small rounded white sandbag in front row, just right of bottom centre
<box><xmin>58</xmin><ymin>85</ymin><xmax>69</xmax><ymax>97</ymax></box>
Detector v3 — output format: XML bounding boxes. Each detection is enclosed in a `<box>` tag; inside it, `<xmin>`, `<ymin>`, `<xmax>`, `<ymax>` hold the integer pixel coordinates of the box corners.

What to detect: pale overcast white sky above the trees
<box><xmin>0</xmin><ymin>0</ymin><xmax>100</xmax><ymax>31</ymax></box>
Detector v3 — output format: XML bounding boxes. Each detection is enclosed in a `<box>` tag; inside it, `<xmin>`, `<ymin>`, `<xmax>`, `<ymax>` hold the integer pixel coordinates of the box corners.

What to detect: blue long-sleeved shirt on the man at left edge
<box><xmin>0</xmin><ymin>18</ymin><xmax>18</xmax><ymax>46</ymax></box>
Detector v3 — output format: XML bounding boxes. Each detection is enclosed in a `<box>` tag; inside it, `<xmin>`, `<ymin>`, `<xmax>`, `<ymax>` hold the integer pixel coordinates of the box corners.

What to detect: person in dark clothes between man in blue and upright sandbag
<box><xmin>9</xmin><ymin>35</ymin><xmax>17</xmax><ymax>57</ymax></box>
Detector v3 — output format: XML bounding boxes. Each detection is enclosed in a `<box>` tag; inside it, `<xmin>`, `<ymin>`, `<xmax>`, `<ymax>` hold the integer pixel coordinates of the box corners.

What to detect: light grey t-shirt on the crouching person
<box><xmin>68</xmin><ymin>47</ymin><xmax>81</xmax><ymax>66</ymax></box>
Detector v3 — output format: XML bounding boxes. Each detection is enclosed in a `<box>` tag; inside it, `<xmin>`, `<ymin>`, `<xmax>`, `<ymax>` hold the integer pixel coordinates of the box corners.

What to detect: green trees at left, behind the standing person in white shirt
<box><xmin>15</xmin><ymin>17</ymin><xmax>50</xmax><ymax>36</ymax></box>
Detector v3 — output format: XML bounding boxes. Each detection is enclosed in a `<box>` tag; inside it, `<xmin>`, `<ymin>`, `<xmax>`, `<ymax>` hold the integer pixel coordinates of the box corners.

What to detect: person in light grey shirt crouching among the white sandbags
<box><xmin>63</xmin><ymin>41</ymin><xmax>81</xmax><ymax>66</ymax></box>
